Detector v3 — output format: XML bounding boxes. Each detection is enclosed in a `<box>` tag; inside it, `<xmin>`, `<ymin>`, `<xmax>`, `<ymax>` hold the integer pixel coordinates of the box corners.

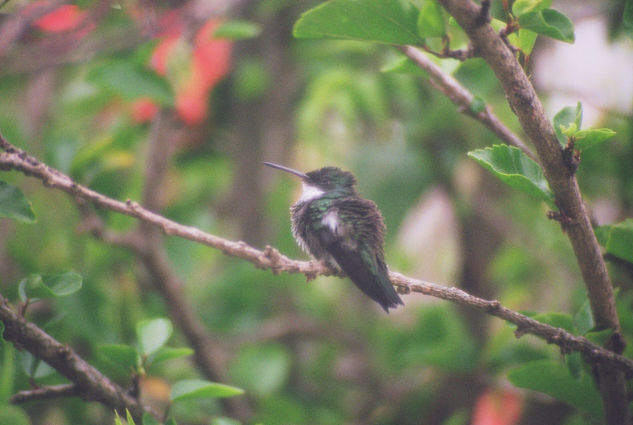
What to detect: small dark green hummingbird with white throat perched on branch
<box><xmin>264</xmin><ymin>162</ymin><xmax>404</xmax><ymax>313</ymax></box>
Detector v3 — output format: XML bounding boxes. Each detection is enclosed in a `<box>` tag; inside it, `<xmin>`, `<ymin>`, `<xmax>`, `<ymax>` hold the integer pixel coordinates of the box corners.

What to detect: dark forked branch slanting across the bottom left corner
<box><xmin>0</xmin><ymin>295</ymin><xmax>158</xmax><ymax>419</ymax></box>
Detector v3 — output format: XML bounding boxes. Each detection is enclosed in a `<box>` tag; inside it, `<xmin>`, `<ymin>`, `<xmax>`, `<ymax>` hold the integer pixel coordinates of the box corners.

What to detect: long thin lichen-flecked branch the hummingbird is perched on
<box><xmin>0</xmin><ymin>136</ymin><xmax>633</xmax><ymax>376</ymax></box>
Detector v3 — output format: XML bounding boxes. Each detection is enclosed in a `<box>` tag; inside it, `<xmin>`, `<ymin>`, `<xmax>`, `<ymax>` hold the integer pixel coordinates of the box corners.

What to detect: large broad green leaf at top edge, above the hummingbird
<box><xmin>293</xmin><ymin>0</ymin><xmax>424</xmax><ymax>45</ymax></box>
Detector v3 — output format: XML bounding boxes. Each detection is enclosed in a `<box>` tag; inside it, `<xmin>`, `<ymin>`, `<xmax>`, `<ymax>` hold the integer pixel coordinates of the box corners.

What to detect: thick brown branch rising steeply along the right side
<box><xmin>440</xmin><ymin>0</ymin><xmax>628</xmax><ymax>424</ymax></box>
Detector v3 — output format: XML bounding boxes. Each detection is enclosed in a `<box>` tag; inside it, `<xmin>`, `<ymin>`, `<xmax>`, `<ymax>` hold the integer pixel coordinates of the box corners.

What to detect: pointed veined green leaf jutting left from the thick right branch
<box><xmin>468</xmin><ymin>145</ymin><xmax>556</xmax><ymax>209</ymax></box>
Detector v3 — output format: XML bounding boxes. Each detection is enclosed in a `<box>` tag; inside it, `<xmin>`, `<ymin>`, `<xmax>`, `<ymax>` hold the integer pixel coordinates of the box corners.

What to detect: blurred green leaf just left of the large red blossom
<box><xmin>88</xmin><ymin>61</ymin><xmax>172</xmax><ymax>105</ymax></box>
